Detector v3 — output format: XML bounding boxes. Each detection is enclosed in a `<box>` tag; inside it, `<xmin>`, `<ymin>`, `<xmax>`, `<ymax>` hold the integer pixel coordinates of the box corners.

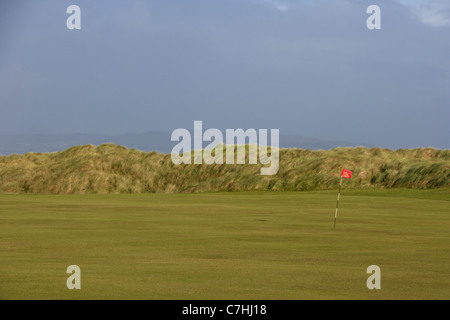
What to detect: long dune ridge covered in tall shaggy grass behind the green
<box><xmin>0</xmin><ymin>144</ymin><xmax>450</xmax><ymax>194</ymax></box>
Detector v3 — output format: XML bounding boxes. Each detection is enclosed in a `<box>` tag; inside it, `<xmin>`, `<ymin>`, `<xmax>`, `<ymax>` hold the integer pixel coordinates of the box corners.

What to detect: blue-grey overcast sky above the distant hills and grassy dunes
<box><xmin>0</xmin><ymin>0</ymin><xmax>450</xmax><ymax>149</ymax></box>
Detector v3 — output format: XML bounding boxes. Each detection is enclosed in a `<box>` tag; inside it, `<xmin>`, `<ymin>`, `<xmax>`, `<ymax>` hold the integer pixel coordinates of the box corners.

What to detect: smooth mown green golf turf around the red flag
<box><xmin>0</xmin><ymin>189</ymin><xmax>450</xmax><ymax>299</ymax></box>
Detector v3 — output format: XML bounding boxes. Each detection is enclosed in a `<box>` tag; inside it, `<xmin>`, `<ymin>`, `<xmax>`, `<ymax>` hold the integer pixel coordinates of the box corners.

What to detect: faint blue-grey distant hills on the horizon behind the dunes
<box><xmin>0</xmin><ymin>131</ymin><xmax>373</xmax><ymax>155</ymax></box>
